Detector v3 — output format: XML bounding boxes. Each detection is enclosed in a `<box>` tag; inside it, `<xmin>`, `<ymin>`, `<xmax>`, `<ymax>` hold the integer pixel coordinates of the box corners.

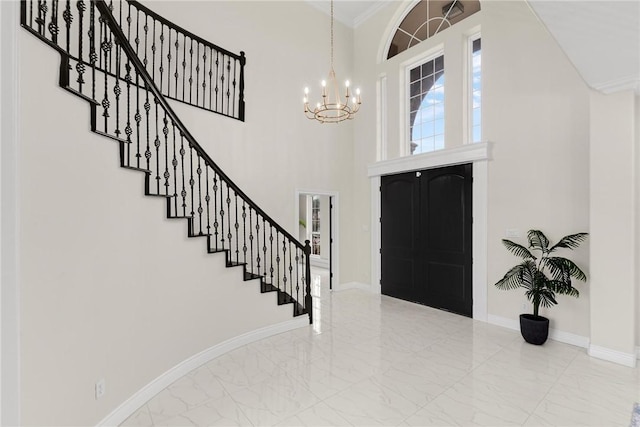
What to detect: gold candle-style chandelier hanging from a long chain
<box><xmin>304</xmin><ymin>0</ymin><xmax>362</xmax><ymax>123</ymax></box>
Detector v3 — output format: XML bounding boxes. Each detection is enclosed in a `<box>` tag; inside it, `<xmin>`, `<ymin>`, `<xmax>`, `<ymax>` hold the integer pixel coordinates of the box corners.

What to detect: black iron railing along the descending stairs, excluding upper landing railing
<box><xmin>21</xmin><ymin>0</ymin><xmax>313</xmax><ymax>322</ymax></box>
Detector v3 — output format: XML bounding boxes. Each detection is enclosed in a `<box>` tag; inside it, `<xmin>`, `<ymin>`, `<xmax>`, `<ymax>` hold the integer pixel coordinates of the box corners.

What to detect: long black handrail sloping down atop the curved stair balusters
<box><xmin>93</xmin><ymin>0</ymin><xmax>309</xmax><ymax>254</ymax></box>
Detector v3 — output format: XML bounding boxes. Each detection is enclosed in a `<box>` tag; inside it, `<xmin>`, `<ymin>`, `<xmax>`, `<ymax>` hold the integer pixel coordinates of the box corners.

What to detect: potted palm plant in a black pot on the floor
<box><xmin>495</xmin><ymin>230</ymin><xmax>588</xmax><ymax>345</ymax></box>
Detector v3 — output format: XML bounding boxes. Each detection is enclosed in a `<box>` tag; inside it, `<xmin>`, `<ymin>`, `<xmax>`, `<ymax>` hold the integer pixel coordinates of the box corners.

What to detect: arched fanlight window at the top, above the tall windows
<box><xmin>387</xmin><ymin>0</ymin><xmax>480</xmax><ymax>59</ymax></box>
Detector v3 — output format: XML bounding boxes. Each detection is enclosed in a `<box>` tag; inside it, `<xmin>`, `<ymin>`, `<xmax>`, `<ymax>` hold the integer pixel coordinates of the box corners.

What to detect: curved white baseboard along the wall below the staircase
<box><xmin>98</xmin><ymin>316</ymin><xmax>309</xmax><ymax>426</ymax></box>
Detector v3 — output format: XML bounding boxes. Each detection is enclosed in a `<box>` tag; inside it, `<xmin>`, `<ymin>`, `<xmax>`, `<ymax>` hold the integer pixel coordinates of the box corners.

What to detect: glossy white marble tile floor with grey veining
<box><xmin>123</xmin><ymin>270</ymin><xmax>640</xmax><ymax>427</ymax></box>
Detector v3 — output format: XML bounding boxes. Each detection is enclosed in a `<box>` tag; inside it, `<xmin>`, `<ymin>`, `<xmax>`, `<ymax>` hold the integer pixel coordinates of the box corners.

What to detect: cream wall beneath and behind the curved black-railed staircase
<box><xmin>16</xmin><ymin>2</ymin><xmax>352</xmax><ymax>425</ymax></box>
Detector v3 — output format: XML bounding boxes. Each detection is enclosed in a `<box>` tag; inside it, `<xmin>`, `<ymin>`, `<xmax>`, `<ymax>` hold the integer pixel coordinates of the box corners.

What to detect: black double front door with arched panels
<box><xmin>381</xmin><ymin>164</ymin><xmax>473</xmax><ymax>316</ymax></box>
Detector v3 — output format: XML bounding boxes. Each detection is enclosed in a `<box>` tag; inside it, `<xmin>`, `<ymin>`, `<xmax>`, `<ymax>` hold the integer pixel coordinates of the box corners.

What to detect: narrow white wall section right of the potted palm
<box><xmin>590</xmin><ymin>91</ymin><xmax>637</xmax><ymax>364</ymax></box>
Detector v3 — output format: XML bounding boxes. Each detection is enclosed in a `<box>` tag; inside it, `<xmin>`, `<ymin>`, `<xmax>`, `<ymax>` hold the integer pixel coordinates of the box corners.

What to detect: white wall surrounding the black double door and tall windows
<box><xmin>354</xmin><ymin>1</ymin><xmax>590</xmax><ymax>337</ymax></box>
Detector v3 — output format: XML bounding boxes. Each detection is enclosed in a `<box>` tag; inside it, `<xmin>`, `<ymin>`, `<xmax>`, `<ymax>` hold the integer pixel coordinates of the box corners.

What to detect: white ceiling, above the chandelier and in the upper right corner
<box><xmin>305</xmin><ymin>0</ymin><xmax>640</xmax><ymax>95</ymax></box>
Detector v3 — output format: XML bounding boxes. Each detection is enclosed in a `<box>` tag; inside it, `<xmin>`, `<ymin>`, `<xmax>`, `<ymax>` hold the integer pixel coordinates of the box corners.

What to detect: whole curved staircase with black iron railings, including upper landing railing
<box><xmin>21</xmin><ymin>0</ymin><xmax>313</xmax><ymax>322</ymax></box>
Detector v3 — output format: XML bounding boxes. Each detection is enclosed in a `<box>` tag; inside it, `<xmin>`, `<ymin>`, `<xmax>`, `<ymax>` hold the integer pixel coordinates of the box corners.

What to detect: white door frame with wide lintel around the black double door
<box><xmin>368</xmin><ymin>142</ymin><xmax>491</xmax><ymax>322</ymax></box>
